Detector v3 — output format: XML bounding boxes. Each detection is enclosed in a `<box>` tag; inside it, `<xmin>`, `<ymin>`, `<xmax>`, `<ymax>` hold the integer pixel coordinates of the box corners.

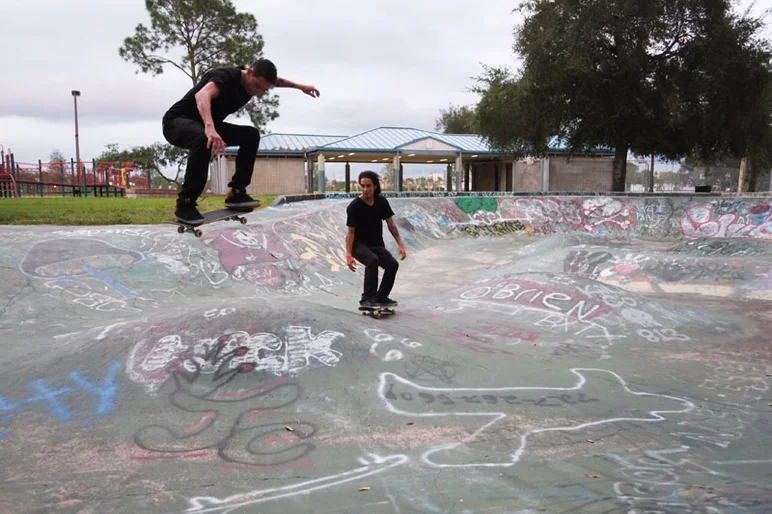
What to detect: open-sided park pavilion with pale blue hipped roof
<box><xmin>222</xmin><ymin>127</ymin><xmax>613</xmax><ymax>194</ymax></box>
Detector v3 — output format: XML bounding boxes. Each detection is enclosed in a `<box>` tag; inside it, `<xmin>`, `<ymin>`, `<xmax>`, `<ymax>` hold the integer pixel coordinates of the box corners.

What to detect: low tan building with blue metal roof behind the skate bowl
<box><xmin>219</xmin><ymin>127</ymin><xmax>614</xmax><ymax>194</ymax></box>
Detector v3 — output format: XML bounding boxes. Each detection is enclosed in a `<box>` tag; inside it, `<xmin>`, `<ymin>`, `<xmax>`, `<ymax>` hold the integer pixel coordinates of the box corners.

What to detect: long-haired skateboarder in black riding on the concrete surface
<box><xmin>346</xmin><ymin>171</ymin><xmax>407</xmax><ymax>309</ymax></box>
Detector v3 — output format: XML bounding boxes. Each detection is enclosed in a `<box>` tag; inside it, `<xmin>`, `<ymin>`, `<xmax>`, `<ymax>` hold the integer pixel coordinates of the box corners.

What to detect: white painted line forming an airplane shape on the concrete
<box><xmin>378</xmin><ymin>368</ymin><xmax>695</xmax><ymax>468</ymax></box>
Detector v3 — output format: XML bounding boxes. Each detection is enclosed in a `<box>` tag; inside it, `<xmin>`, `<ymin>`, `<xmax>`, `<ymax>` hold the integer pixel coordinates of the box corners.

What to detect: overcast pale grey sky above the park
<box><xmin>0</xmin><ymin>0</ymin><xmax>772</xmax><ymax>171</ymax></box>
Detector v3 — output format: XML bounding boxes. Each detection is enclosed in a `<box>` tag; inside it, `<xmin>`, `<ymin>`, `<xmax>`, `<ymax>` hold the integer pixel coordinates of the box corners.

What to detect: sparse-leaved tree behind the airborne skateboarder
<box><xmin>119</xmin><ymin>0</ymin><xmax>279</xmax><ymax>131</ymax></box>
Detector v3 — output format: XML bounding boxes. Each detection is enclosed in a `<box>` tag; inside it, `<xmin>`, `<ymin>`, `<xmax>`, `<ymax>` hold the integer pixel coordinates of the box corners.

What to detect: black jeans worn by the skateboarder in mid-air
<box><xmin>163</xmin><ymin>118</ymin><xmax>260</xmax><ymax>201</ymax></box>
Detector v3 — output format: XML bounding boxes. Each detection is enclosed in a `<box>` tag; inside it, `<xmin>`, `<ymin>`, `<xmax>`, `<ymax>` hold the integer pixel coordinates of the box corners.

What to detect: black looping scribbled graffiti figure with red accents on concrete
<box><xmin>134</xmin><ymin>335</ymin><xmax>316</xmax><ymax>467</ymax></box>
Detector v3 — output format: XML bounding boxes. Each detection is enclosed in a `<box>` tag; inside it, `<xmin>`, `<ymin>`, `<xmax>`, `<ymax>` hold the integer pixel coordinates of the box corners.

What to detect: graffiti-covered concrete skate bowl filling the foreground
<box><xmin>0</xmin><ymin>196</ymin><xmax>772</xmax><ymax>513</ymax></box>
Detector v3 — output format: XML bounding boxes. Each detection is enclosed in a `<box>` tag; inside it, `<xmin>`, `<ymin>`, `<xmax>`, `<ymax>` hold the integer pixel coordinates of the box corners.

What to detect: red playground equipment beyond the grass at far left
<box><xmin>0</xmin><ymin>152</ymin><xmax>150</xmax><ymax>198</ymax></box>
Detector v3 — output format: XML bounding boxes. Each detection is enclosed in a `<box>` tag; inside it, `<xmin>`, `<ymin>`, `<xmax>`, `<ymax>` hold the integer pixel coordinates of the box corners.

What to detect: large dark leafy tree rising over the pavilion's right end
<box><xmin>477</xmin><ymin>0</ymin><xmax>768</xmax><ymax>191</ymax></box>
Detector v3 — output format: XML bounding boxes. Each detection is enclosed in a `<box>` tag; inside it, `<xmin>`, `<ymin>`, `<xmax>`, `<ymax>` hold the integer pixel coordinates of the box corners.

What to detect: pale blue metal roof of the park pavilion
<box><xmin>225</xmin><ymin>127</ymin><xmax>608</xmax><ymax>155</ymax></box>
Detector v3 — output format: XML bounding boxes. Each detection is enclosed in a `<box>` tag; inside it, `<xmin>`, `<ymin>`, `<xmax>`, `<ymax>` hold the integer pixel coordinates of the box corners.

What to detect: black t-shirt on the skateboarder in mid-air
<box><xmin>163</xmin><ymin>66</ymin><xmax>252</xmax><ymax>123</ymax></box>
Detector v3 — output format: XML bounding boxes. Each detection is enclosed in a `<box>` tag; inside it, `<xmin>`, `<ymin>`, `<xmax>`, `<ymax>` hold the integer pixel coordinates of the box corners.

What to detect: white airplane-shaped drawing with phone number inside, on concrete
<box><xmin>378</xmin><ymin>368</ymin><xmax>695</xmax><ymax>468</ymax></box>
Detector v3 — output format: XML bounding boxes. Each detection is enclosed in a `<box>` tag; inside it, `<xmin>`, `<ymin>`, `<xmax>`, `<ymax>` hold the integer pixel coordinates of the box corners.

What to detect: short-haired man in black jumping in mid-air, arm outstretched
<box><xmin>163</xmin><ymin>59</ymin><xmax>319</xmax><ymax>225</ymax></box>
